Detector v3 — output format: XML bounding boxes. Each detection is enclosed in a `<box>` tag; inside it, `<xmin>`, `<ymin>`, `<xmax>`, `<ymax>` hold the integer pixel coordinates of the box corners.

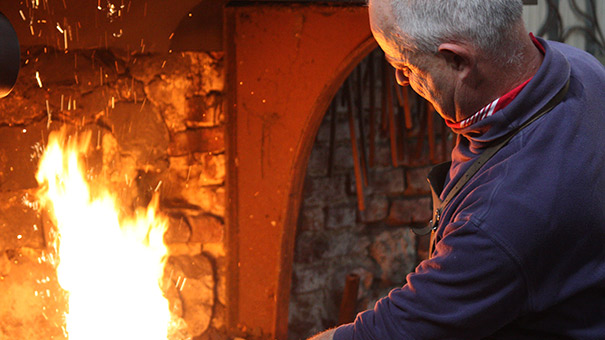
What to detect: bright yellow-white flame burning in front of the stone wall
<box><xmin>36</xmin><ymin>130</ymin><xmax>170</xmax><ymax>340</ymax></box>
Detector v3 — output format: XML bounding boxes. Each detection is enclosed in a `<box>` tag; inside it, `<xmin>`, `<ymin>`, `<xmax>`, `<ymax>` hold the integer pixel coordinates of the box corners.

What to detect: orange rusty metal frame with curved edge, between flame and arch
<box><xmin>224</xmin><ymin>2</ymin><xmax>377</xmax><ymax>339</ymax></box>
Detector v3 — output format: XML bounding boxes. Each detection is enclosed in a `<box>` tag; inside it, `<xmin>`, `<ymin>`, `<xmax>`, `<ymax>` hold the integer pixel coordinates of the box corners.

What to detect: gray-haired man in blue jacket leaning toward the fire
<box><xmin>312</xmin><ymin>0</ymin><xmax>605</xmax><ymax>340</ymax></box>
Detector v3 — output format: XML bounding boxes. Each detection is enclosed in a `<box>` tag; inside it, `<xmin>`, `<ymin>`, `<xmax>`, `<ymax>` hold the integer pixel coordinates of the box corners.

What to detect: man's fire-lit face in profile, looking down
<box><xmin>369</xmin><ymin>0</ymin><xmax>455</xmax><ymax>119</ymax></box>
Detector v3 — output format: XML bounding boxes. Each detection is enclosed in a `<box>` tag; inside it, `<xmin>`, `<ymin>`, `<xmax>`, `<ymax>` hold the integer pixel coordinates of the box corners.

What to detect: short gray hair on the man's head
<box><xmin>387</xmin><ymin>0</ymin><xmax>523</xmax><ymax>62</ymax></box>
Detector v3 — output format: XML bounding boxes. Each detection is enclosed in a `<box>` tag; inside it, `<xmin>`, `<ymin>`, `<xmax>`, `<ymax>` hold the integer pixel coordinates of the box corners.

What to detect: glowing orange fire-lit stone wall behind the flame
<box><xmin>0</xmin><ymin>47</ymin><xmax>226</xmax><ymax>340</ymax></box>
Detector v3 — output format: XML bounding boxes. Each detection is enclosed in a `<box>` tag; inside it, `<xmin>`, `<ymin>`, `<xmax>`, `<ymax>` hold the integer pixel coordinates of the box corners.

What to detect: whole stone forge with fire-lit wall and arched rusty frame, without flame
<box><xmin>0</xmin><ymin>0</ymin><xmax>576</xmax><ymax>340</ymax></box>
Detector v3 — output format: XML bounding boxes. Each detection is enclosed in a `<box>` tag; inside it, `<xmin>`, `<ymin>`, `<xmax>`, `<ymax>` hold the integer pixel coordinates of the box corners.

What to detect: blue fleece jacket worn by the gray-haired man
<box><xmin>334</xmin><ymin>39</ymin><xmax>605</xmax><ymax>340</ymax></box>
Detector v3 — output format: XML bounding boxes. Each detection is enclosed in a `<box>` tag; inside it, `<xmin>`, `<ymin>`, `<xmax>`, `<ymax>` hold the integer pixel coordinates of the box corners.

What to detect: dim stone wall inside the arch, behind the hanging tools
<box><xmin>289</xmin><ymin>51</ymin><xmax>451</xmax><ymax>340</ymax></box>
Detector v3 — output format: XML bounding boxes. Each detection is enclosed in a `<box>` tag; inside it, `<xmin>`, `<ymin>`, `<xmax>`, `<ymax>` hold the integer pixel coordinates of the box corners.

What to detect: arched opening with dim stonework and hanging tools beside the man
<box><xmin>289</xmin><ymin>49</ymin><xmax>453</xmax><ymax>340</ymax></box>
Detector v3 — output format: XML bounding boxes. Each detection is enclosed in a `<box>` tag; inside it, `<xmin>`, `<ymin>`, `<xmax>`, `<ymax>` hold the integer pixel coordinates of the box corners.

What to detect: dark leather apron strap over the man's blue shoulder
<box><xmin>413</xmin><ymin>79</ymin><xmax>569</xmax><ymax>258</ymax></box>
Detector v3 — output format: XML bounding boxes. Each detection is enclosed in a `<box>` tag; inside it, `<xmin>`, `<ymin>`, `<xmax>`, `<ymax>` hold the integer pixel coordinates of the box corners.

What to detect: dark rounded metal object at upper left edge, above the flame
<box><xmin>0</xmin><ymin>13</ymin><xmax>21</xmax><ymax>98</ymax></box>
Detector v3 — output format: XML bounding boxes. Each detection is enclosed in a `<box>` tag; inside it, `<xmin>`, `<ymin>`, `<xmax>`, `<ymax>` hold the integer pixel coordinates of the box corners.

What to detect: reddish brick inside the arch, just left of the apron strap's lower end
<box><xmin>387</xmin><ymin>197</ymin><xmax>432</xmax><ymax>226</ymax></box>
